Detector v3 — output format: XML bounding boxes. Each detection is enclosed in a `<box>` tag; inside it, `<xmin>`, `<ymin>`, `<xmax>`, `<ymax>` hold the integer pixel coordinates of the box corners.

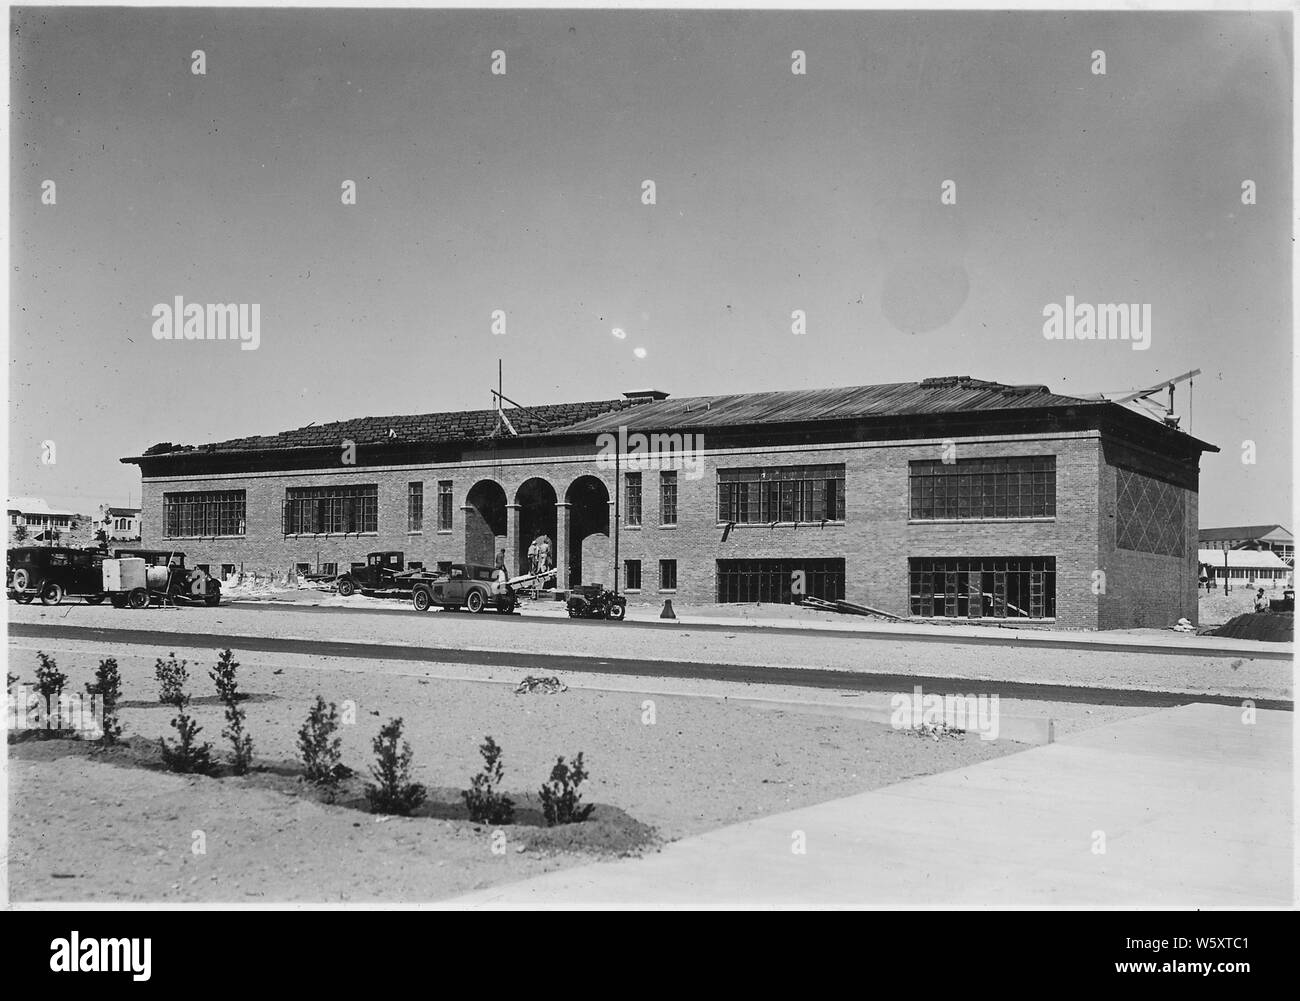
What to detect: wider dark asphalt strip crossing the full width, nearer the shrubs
<box><xmin>9</xmin><ymin>616</ymin><xmax>1294</xmax><ymax>711</ymax></box>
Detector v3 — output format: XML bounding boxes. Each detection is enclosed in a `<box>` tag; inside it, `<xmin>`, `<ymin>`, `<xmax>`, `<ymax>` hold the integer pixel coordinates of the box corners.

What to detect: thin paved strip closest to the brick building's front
<box><xmin>225</xmin><ymin>599</ymin><xmax>1294</xmax><ymax>660</ymax></box>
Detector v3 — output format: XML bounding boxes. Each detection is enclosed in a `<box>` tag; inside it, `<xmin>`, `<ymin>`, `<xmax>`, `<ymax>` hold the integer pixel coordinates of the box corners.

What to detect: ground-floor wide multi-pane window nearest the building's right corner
<box><xmin>907</xmin><ymin>556</ymin><xmax>1056</xmax><ymax>619</ymax></box>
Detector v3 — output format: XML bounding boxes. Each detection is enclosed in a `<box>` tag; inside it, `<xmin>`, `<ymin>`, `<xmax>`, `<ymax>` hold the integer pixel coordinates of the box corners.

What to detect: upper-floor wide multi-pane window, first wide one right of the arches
<box><xmin>718</xmin><ymin>463</ymin><xmax>844</xmax><ymax>525</ymax></box>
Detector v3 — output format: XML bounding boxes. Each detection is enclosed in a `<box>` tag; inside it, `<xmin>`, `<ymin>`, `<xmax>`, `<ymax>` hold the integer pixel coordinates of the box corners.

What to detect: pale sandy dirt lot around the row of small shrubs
<box><xmin>8</xmin><ymin>644</ymin><xmax>1029</xmax><ymax>902</ymax></box>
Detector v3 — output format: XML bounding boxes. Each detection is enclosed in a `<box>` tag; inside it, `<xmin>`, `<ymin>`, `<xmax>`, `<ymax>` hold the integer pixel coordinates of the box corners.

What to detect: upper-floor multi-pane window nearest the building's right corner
<box><xmin>907</xmin><ymin>455</ymin><xmax>1056</xmax><ymax>521</ymax></box>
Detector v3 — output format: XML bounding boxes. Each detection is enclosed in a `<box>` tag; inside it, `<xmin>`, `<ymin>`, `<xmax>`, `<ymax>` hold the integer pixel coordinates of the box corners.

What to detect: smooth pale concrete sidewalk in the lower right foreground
<box><xmin>449</xmin><ymin>705</ymin><xmax>1295</xmax><ymax>907</ymax></box>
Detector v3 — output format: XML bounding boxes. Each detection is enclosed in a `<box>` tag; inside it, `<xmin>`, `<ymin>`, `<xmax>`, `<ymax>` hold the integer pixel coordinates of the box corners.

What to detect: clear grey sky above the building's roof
<box><xmin>9</xmin><ymin>8</ymin><xmax>1294</xmax><ymax>528</ymax></box>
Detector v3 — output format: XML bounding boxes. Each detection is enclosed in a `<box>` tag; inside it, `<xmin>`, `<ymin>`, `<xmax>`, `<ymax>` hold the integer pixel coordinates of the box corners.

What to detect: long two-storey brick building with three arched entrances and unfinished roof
<box><xmin>122</xmin><ymin>377</ymin><xmax>1218</xmax><ymax>629</ymax></box>
